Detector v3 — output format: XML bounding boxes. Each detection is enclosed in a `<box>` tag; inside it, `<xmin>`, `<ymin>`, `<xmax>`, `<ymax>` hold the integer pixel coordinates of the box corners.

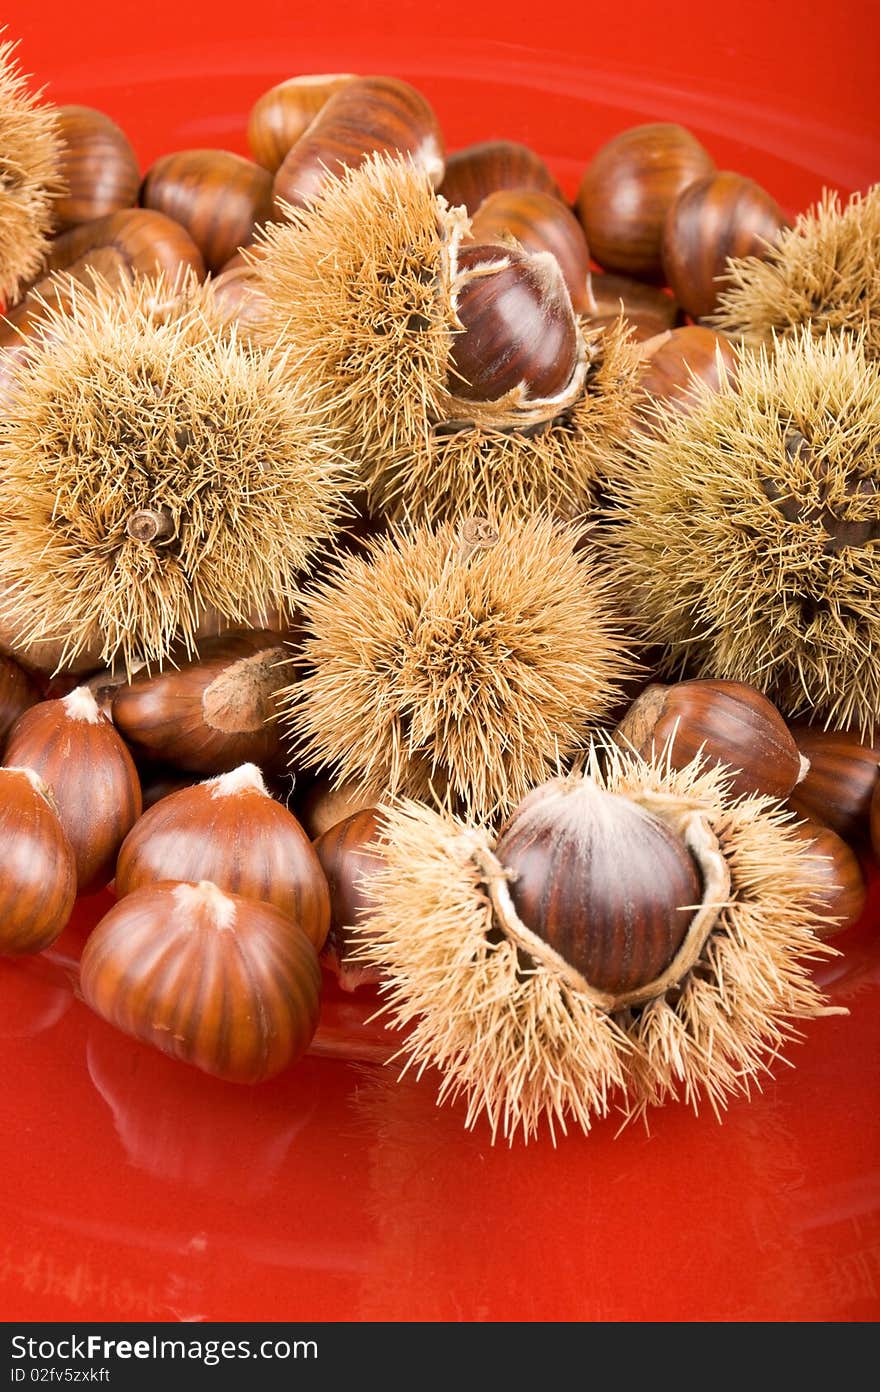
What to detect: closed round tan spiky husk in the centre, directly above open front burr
<box><xmin>278</xmin><ymin>516</ymin><xmax>634</xmax><ymax>817</ymax></box>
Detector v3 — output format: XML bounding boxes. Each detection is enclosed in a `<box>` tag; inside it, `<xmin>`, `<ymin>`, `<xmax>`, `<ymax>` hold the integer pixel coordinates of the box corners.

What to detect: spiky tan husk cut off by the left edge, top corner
<box><xmin>0</xmin><ymin>42</ymin><xmax>61</xmax><ymax>303</ymax></box>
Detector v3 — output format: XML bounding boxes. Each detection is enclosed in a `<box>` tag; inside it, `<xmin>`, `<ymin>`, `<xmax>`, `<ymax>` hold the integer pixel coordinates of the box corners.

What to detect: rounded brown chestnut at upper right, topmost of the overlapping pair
<box><xmin>576</xmin><ymin>122</ymin><xmax>714</xmax><ymax>281</ymax></box>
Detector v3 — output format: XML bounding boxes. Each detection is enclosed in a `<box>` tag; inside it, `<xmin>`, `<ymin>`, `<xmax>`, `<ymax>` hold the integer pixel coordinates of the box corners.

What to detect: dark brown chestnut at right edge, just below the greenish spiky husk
<box><xmin>789</xmin><ymin>725</ymin><xmax>880</xmax><ymax>844</ymax></box>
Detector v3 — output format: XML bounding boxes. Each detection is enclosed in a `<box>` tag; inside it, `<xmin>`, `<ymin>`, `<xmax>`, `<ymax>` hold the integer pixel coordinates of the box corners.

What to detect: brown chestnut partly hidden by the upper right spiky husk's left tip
<box><xmin>661</xmin><ymin>170</ymin><xmax>788</xmax><ymax>319</ymax></box>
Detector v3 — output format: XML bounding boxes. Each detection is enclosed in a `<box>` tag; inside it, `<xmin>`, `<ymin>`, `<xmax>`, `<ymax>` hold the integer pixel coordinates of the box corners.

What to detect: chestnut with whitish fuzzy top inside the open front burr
<box><xmin>494</xmin><ymin>780</ymin><xmax>703</xmax><ymax>995</ymax></box>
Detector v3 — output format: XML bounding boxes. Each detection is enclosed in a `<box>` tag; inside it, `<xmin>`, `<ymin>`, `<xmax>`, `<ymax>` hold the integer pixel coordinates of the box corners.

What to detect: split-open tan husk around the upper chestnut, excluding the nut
<box><xmin>252</xmin><ymin>157</ymin><xmax>639</xmax><ymax>521</ymax></box>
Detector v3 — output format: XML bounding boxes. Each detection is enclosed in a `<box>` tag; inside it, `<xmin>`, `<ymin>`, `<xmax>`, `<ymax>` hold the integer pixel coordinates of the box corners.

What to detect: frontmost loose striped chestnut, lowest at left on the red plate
<box><xmin>79</xmin><ymin>883</ymin><xmax>320</xmax><ymax>1083</ymax></box>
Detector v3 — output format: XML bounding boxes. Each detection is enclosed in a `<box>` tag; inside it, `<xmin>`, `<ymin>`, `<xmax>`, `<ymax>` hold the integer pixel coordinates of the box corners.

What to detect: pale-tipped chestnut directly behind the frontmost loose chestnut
<box><xmin>116</xmin><ymin>764</ymin><xmax>330</xmax><ymax>949</ymax></box>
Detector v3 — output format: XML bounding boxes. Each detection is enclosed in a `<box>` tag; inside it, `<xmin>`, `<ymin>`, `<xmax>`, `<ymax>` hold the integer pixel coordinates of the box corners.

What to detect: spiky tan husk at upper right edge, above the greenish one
<box><xmin>713</xmin><ymin>184</ymin><xmax>880</xmax><ymax>358</ymax></box>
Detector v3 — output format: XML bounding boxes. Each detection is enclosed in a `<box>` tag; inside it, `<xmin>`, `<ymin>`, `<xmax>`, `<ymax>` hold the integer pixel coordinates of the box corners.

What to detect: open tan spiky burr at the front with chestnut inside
<box><xmin>355</xmin><ymin>748</ymin><xmax>833</xmax><ymax>1141</ymax></box>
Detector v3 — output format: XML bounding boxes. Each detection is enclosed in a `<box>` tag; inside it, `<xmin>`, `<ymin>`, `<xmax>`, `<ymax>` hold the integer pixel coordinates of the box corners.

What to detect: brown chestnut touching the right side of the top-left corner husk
<box><xmin>53</xmin><ymin>106</ymin><xmax>141</xmax><ymax>232</ymax></box>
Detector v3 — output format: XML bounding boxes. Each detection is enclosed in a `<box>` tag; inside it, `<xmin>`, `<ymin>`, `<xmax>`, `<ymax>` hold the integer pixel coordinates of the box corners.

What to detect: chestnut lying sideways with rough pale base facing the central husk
<box><xmin>113</xmin><ymin>629</ymin><xmax>291</xmax><ymax>779</ymax></box>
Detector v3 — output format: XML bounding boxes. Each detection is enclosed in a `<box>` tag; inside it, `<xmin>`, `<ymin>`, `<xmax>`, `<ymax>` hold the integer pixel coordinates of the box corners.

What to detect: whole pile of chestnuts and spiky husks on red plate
<box><xmin>0</xmin><ymin>38</ymin><xmax>880</xmax><ymax>1139</ymax></box>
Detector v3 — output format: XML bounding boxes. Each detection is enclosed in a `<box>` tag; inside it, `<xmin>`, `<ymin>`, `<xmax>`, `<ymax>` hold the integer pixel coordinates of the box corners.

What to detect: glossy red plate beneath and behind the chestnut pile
<box><xmin>0</xmin><ymin>0</ymin><xmax>880</xmax><ymax>1321</ymax></box>
